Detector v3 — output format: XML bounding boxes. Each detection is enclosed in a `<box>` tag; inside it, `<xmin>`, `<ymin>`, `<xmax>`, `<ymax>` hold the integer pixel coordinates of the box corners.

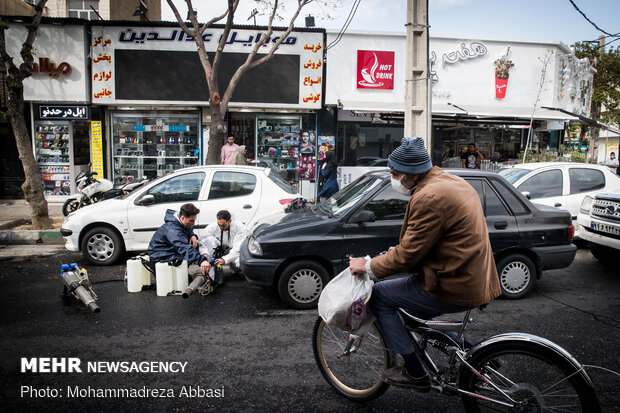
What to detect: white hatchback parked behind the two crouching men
<box><xmin>60</xmin><ymin>165</ymin><xmax>299</xmax><ymax>265</ymax></box>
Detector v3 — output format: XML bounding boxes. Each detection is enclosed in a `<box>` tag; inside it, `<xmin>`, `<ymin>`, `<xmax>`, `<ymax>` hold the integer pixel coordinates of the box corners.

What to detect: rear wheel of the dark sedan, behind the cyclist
<box><xmin>497</xmin><ymin>254</ymin><xmax>536</xmax><ymax>300</ymax></box>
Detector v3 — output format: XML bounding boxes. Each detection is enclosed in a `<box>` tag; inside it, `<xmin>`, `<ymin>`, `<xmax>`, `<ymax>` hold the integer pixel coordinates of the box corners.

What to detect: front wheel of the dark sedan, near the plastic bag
<box><xmin>278</xmin><ymin>260</ymin><xmax>329</xmax><ymax>310</ymax></box>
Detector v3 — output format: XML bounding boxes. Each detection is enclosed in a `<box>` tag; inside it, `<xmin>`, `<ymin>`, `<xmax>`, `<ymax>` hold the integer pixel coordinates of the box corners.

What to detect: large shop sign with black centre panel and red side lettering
<box><xmin>90</xmin><ymin>26</ymin><xmax>325</xmax><ymax>109</ymax></box>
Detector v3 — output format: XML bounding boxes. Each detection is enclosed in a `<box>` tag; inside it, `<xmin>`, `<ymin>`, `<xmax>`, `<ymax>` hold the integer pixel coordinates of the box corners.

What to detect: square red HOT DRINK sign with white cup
<box><xmin>357</xmin><ymin>50</ymin><xmax>394</xmax><ymax>89</ymax></box>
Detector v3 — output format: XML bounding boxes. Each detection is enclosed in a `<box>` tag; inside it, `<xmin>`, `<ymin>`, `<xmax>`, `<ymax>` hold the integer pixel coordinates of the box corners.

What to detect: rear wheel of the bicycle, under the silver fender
<box><xmin>459</xmin><ymin>341</ymin><xmax>600</xmax><ymax>413</ymax></box>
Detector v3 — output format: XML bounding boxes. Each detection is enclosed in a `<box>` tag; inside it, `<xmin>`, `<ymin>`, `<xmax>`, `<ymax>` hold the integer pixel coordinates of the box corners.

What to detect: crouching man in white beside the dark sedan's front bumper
<box><xmin>199</xmin><ymin>209</ymin><xmax>250</xmax><ymax>272</ymax></box>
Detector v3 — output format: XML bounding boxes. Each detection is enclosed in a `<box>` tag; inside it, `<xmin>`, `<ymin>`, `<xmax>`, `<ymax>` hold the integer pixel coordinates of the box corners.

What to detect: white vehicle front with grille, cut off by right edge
<box><xmin>577</xmin><ymin>191</ymin><xmax>620</xmax><ymax>265</ymax></box>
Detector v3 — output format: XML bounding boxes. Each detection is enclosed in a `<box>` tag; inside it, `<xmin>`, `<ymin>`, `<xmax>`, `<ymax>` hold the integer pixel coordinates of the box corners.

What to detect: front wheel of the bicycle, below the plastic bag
<box><xmin>312</xmin><ymin>317</ymin><xmax>392</xmax><ymax>401</ymax></box>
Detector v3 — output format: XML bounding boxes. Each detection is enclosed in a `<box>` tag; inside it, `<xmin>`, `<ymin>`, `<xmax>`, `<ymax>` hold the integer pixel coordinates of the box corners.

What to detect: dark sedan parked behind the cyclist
<box><xmin>241</xmin><ymin>169</ymin><xmax>576</xmax><ymax>309</ymax></box>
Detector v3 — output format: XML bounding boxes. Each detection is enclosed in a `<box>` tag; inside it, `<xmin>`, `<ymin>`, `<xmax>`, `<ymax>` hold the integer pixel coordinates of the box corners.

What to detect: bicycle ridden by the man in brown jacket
<box><xmin>312</xmin><ymin>309</ymin><xmax>600</xmax><ymax>412</ymax></box>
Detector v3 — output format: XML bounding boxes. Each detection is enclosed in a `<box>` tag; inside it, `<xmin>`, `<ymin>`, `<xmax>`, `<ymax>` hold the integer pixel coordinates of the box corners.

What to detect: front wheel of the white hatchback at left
<box><xmin>82</xmin><ymin>227</ymin><xmax>125</xmax><ymax>265</ymax></box>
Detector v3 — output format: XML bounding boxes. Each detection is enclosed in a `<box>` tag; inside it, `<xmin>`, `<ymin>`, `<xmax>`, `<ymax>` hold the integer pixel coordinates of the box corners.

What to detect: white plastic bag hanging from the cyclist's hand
<box><xmin>319</xmin><ymin>267</ymin><xmax>375</xmax><ymax>334</ymax></box>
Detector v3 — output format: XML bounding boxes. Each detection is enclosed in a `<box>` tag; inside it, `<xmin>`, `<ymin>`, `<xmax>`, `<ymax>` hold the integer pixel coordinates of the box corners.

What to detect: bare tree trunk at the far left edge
<box><xmin>0</xmin><ymin>0</ymin><xmax>52</xmax><ymax>229</ymax></box>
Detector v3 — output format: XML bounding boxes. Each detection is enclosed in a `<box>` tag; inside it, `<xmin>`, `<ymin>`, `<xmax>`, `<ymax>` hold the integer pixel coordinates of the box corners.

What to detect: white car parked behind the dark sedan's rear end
<box><xmin>498</xmin><ymin>162</ymin><xmax>620</xmax><ymax>239</ymax></box>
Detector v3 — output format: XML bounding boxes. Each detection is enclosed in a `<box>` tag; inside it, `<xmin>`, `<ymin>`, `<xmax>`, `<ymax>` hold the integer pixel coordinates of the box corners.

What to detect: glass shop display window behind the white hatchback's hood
<box><xmin>111</xmin><ymin>111</ymin><xmax>200</xmax><ymax>183</ymax></box>
